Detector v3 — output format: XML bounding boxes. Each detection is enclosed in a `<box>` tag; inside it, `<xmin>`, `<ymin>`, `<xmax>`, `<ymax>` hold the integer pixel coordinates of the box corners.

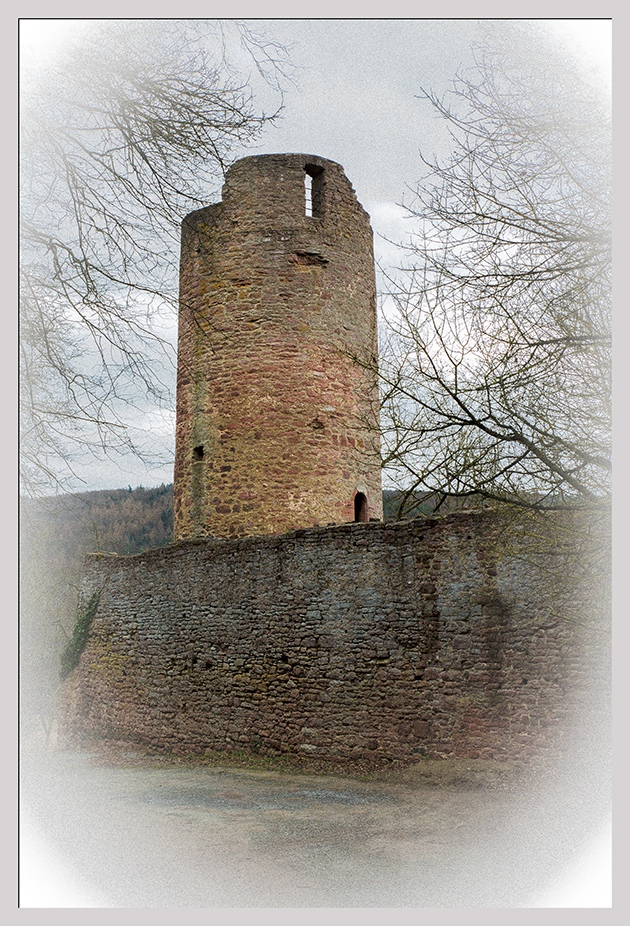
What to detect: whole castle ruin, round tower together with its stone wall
<box><xmin>60</xmin><ymin>154</ymin><xmax>609</xmax><ymax>762</ymax></box>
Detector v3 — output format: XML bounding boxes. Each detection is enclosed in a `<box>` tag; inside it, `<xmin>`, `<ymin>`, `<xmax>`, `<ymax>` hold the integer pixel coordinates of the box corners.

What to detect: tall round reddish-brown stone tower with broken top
<box><xmin>175</xmin><ymin>154</ymin><xmax>382</xmax><ymax>540</ymax></box>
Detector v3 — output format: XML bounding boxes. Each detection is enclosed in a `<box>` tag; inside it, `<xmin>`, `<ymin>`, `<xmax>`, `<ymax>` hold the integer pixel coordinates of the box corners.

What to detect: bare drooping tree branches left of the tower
<box><xmin>20</xmin><ymin>20</ymin><xmax>288</xmax><ymax>494</ymax></box>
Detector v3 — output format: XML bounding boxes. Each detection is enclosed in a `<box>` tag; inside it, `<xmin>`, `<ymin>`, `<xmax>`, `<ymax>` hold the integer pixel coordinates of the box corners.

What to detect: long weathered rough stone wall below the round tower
<box><xmin>61</xmin><ymin>512</ymin><xmax>608</xmax><ymax>760</ymax></box>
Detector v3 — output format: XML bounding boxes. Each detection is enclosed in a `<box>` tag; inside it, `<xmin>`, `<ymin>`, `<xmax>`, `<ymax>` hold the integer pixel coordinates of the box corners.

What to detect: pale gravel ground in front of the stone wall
<box><xmin>20</xmin><ymin>748</ymin><xmax>610</xmax><ymax>908</ymax></box>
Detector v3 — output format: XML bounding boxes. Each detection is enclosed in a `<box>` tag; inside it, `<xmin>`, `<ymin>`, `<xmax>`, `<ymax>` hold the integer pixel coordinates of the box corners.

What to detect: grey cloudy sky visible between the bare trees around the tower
<box><xmin>22</xmin><ymin>19</ymin><xmax>611</xmax><ymax>490</ymax></box>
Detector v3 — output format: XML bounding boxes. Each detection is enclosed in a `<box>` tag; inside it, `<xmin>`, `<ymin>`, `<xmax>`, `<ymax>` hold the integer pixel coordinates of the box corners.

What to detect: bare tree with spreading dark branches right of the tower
<box><xmin>380</xmin><ymin>24</ymin><xmax>611</xmax><ymax>510</ymax></box>
